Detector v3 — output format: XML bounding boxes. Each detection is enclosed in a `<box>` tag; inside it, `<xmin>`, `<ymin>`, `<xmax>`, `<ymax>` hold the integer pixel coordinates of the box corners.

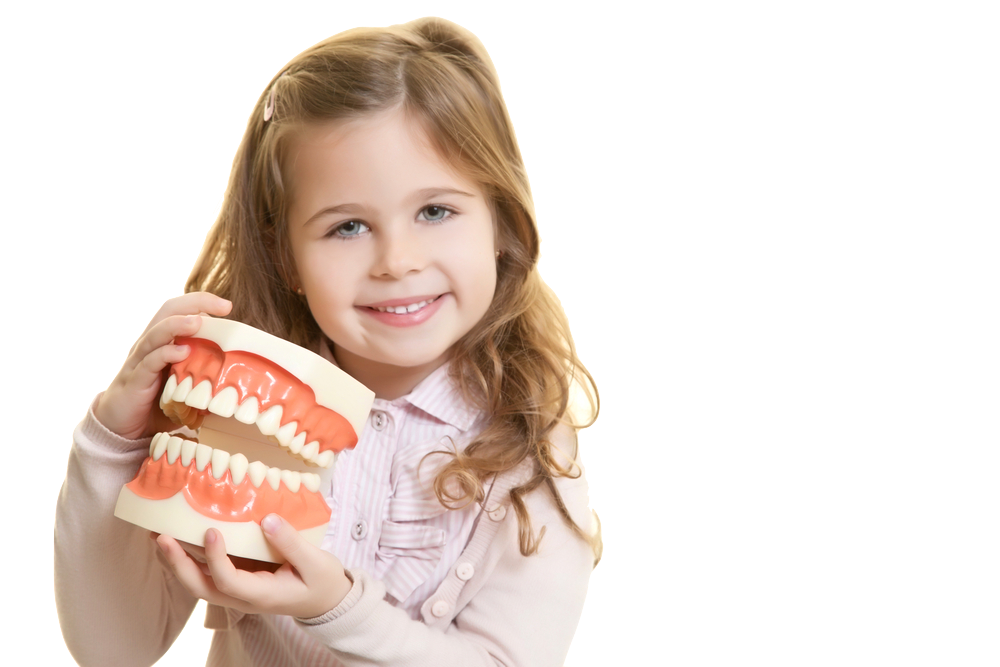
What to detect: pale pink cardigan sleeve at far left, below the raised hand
<box><xmin>52</xmin><ymin>394</ymin><xmax>197</xmax><ymax>666</ymax></box>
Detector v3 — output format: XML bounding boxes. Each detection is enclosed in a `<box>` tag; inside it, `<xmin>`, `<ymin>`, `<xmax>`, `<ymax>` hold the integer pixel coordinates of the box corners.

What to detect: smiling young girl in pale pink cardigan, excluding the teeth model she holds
<box><xmin>53</xmin><ymin>18</ymin><xmax>603</xmax><ymax>667</ymax></box>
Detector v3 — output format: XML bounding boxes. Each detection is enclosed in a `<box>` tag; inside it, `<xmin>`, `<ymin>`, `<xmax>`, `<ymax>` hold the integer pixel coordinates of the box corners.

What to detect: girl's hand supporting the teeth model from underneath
<box><xmin>150</xmin><ymin>514</ymin><xmax>353</xmax><ymax>618</ymax></box>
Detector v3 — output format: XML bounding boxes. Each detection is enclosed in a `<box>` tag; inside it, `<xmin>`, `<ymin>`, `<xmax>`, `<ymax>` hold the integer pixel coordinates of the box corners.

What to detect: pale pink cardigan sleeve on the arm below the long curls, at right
<box><xmin>296</xmin><ymin>426</ymin><xmax>597</xmax><ymax>667</ymax></box>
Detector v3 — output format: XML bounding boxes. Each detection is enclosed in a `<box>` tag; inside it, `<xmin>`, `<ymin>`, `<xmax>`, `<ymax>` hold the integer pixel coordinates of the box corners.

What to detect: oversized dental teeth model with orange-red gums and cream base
<box><xmin>115</xmin><ymin>317</ymin><xmax>375</xmax><ymax>563</ymax></box>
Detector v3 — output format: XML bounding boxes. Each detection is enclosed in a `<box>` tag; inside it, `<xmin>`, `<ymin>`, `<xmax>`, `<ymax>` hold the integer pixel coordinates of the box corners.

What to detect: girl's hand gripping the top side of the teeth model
<box><xmin>94</xmin><ymin>292</ymin><xmax>233</xmax><ymax>440</ymax></box>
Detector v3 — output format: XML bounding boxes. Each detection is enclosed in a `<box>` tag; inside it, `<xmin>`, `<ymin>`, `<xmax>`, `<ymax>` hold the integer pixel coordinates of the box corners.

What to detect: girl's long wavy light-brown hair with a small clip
<box><xmin>184</xmin><ymin>17</ymin><xmax>603</xmax><ymax>567</ymax></box>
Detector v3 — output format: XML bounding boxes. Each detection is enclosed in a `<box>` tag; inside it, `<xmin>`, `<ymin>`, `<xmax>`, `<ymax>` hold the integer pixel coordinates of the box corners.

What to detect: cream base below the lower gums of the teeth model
<box><xmin>115</xmin><ymin>486</ymin><xmax>326</xmax><ymax>563</ymax></box>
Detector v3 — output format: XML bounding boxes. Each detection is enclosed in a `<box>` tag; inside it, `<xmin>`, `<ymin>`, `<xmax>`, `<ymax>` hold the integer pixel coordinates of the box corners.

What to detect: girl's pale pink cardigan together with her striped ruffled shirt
<box><xmin>52</xmin><ymin>355</ymin><xmax>599</xmax><ymax>667</ymax></box>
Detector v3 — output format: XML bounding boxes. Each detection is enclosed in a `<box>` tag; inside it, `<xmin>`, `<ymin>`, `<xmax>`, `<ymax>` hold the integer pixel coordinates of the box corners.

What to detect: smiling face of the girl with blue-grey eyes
<box><xmin>288</xmin><ymin>111</ymin><xmax>497</xmax><ymax>399</ymax></box>
